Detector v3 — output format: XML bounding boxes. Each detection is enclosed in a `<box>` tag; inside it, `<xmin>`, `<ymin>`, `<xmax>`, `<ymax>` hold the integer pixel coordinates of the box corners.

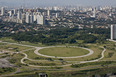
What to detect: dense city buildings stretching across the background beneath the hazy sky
<box><xmin>0</xmin><ymin>6</ymin><xmax>116</xmax><ymax>33</ymax></box>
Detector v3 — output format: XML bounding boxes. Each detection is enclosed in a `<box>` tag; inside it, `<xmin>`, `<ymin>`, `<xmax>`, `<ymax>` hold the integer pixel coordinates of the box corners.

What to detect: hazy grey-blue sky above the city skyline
<box><xmin>0</xmin><ymin>0</ymin><xmax>116</xmax><ymax>7</ymax></box>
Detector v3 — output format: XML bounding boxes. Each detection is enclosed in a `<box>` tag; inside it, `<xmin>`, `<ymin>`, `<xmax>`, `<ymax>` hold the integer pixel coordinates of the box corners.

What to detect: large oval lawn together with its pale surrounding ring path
<box><xmin>34</xmin><ymin>46</ymin><xmax>94</xmax><ymax>58</ymax></box>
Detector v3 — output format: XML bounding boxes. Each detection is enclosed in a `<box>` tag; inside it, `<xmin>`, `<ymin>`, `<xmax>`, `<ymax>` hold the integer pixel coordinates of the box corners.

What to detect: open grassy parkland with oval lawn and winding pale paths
<box><xmin>0</xmin><ymin>38</ymin><xmax>116</xmax><ymax>76</ymax></box>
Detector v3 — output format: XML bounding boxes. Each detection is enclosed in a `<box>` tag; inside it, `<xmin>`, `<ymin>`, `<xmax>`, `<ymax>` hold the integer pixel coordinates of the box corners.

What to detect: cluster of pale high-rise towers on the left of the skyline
<box><xmin>1</xmin><ymin>7</ymin><xmax>45</xmax><ymax>25</ymax></box>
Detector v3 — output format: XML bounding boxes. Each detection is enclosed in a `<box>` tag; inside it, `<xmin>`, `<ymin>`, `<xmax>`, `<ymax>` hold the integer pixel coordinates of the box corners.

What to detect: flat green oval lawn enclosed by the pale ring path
<box><xmin>39</xmin><ymin>47</ymin><xmax>89</xmax><ymax>57</ymax></box>
